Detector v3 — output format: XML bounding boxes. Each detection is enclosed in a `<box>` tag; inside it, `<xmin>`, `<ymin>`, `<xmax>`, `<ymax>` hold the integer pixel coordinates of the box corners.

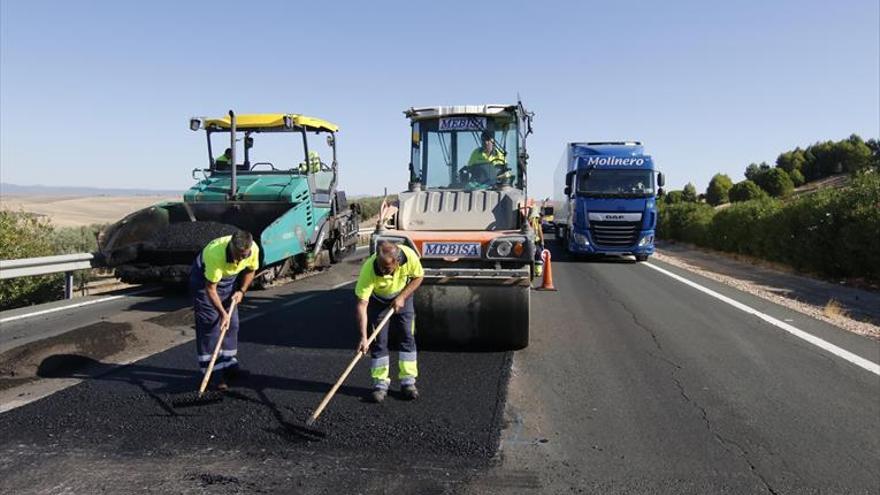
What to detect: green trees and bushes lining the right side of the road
<box><xmin>657</xmin><ymin>135</ymin><xmax>880</xmax><ymax>284</ymax></box>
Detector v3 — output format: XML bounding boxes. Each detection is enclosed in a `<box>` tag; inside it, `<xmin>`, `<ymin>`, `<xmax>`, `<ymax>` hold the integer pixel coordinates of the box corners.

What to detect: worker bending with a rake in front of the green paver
<box><xmin>189</xmin><ymin>230</ymin><xmax>260</xmax><ymax>391</ymax></box>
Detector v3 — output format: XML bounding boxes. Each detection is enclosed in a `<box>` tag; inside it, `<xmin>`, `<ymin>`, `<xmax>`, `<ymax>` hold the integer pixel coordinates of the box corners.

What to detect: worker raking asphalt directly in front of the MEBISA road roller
<box><xmin>354</xmin><ymin>242</ymin><xmax>425</xmax><ymax>403</ymax></box>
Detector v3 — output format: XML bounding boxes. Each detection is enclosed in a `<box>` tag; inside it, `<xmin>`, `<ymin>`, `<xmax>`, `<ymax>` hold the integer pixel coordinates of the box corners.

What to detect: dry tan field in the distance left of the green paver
<box><xmin>0</xmin><ymin>194</ymin><xmax>180</xmax><ymax>227</ymax></box>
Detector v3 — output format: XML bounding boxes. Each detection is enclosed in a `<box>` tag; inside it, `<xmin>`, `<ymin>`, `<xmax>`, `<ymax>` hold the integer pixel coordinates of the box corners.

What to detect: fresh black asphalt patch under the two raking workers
<box><xmin>0</xmin><ymin>274</ymin><xmax>511</xmax><ymax>492</ymax></box>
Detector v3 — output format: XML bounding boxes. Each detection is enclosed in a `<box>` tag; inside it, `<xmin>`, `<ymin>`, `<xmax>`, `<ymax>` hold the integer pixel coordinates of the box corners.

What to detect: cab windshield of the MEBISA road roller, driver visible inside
<box><xmin>412</xmin><ymin>117</ymin><xmax>522</xmax><ymax>190</ymax></box>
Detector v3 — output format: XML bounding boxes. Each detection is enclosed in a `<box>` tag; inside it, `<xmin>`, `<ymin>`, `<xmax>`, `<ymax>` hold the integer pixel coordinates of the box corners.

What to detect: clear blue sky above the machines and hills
<box><xmin>0</xmin><ymin>0</ymin><xmax>880</xmax><ymax>196</ymax></box>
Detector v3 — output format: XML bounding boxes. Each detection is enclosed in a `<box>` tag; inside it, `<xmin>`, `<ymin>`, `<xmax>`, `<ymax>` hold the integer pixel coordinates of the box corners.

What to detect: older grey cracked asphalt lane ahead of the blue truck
<box><xmin>465</xmin><ymin>244</ymin><xmax>880</xmax><ymax>494</ymax></box>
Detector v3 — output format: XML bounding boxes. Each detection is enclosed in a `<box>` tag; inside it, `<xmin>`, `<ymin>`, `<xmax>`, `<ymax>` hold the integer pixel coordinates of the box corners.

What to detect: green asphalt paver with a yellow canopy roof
<box><xmin>98</xmin><ymin>111</ymin><xmax>358</xmax><ymax>285</ymax></box>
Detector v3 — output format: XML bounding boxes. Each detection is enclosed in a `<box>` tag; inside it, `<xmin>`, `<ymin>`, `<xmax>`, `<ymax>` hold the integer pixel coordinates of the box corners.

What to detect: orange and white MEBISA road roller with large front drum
<box><xmin>371</xmin><ymin>103</ymin><xmax>536</xmax><ymax>349</ymax></box>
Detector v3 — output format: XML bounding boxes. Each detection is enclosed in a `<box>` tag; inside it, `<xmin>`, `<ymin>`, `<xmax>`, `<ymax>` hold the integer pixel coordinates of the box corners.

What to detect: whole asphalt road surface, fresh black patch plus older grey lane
<box><xmin>0</xmin><ymin>242</ymin><xmax>880</xmax><ymax>494</ymax></box>
